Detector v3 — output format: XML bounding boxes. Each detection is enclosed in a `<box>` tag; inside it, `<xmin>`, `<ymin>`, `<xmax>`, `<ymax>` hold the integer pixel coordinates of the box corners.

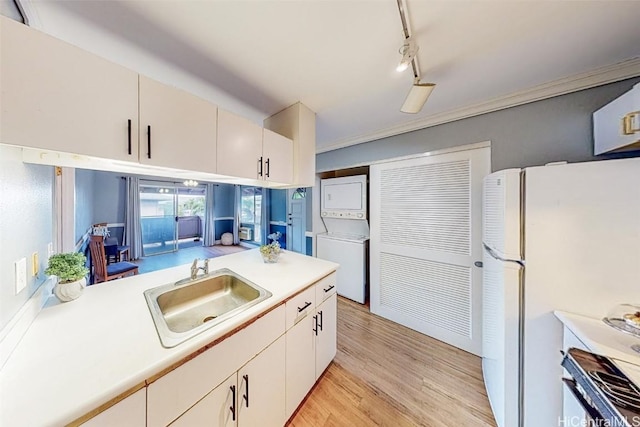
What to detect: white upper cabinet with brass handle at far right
<box><xmin>593</xmin><ymin>83</ymin><xmax>640</xmax><ymax>155</ymax></box>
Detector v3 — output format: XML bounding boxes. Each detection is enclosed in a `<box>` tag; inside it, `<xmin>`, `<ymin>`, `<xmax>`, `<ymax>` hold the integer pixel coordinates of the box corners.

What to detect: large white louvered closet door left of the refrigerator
<box><xmin>370</xmin><ymin>147</ymin><xmax>491</xmax><ymax>355</ymax></box>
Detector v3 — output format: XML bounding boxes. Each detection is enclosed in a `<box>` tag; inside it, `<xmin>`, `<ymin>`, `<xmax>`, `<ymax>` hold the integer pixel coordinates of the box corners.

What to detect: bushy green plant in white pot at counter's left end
<box><xmin>44</xmin><ymin>252</ymin><xmax>89</xmax><ymax>302</ymax></box>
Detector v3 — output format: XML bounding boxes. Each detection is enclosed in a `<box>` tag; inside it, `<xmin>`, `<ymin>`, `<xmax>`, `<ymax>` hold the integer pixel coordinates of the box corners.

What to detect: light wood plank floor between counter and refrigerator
<box><xmin>288</xmin><ymin>297</ymin><xmax>495</xmax><ymax>427</ymax></box>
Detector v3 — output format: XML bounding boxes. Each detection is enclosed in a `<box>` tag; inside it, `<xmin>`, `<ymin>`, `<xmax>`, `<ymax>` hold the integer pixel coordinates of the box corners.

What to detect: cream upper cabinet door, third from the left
<box><xmin>217</xmin><ymin>109</ymin><xmax>264</xmax><ymax>179</ymax></box>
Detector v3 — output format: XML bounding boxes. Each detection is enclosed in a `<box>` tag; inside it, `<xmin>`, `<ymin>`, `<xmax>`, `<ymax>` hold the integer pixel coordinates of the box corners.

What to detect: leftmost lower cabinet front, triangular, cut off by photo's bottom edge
<box><xmin>82</xmin><ymin>388</ymin><xmax>147</xmax><ymax>427</ymax></box>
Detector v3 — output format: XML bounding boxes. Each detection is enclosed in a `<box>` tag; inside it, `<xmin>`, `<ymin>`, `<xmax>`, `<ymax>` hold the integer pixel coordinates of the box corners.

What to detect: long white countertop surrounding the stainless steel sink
<box><xmin>0</xmin><ymin>249</ymin><xmax>338</xmax><ymax>427</ymax></box>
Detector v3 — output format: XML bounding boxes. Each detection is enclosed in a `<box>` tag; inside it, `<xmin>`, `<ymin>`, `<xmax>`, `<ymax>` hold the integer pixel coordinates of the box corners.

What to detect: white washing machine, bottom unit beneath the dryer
<box><xmin>316</xmin><ymin>233</ymin><xmax>369</xmax><ymax>304</ymax></box>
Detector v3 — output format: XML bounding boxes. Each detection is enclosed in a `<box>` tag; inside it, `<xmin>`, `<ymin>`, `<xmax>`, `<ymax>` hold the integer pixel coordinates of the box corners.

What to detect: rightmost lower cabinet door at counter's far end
<box><xmin>316</xmin><ymin>293</ymin><xmax>338</xmax><ymax>379</ymax></box>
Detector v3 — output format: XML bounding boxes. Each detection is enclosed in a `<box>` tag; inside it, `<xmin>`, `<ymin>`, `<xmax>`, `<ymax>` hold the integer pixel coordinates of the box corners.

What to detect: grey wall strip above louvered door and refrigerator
<box><xmin>316</xmin><ymin>78</ymin><xmax>640</xmax><ymax>171</ymax></box>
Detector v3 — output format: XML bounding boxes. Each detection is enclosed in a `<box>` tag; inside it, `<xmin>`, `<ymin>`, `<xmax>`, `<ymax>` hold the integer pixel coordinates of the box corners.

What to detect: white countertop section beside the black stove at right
<box><xmin>554</xmin><ymin>311</ymin><xmax>640</xmax><ymax>385</ymax></box>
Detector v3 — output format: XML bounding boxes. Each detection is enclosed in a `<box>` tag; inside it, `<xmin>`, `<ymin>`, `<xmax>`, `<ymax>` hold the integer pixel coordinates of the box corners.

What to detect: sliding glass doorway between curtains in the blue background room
<box><xmin>140</xmin><ymin>182</ymin><xmax>206</xmax><ymax>256</ymax></box>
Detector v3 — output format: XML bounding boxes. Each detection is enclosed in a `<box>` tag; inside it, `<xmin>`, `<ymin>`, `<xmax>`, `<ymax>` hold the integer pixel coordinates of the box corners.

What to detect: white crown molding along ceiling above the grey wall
<box><xmin>316</xmin><ymin>57</ymin><xmax>640</xmax><ymax>154</ymax></box>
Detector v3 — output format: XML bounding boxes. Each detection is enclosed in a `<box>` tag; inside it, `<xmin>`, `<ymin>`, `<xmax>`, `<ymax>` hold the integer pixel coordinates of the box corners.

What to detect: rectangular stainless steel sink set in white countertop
<box><xmin>144</xmin><ymin>268</ymin><xmax>271</xmax><ymax>348</ymax></box>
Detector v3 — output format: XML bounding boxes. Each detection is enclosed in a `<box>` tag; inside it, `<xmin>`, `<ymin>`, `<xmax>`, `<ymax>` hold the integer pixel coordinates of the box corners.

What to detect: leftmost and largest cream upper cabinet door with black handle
<box><xmin>0</xmin><ymin>17</ymin><xmax>138</xmax><ymax>162</ymax></box>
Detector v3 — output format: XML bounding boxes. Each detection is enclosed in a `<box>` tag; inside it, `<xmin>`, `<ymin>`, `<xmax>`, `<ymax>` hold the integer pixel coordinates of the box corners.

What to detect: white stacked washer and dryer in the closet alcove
<box><xmin>316</xmin><ymin>175</ymin><xmax>369</xmax><ymax>304</ymax></box>
